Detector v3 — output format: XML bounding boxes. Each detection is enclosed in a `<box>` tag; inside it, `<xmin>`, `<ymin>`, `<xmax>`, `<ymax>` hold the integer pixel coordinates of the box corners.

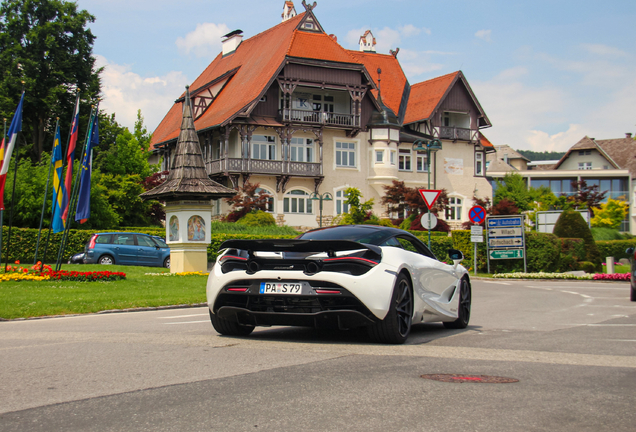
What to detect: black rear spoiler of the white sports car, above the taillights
<box><xmin>219</xmin><ymin>239</ymin><xmax>382</xmax><ymax>257</ymax></box>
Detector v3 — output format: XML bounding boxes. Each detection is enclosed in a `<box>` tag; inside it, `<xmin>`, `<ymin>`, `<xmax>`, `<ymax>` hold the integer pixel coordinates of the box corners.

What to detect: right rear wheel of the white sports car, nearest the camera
<box><xmin>369</xmin><ymin>273</ymin><xmax>413</xmax><ymax>344</ymax></box>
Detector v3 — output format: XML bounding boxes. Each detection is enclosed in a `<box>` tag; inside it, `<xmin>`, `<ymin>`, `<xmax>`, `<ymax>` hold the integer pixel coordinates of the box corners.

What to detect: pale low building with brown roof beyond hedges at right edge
<box><xmin>488</xmin><ymin>133</ymin><xmax>636</xmax><ymax>234</ymax></box>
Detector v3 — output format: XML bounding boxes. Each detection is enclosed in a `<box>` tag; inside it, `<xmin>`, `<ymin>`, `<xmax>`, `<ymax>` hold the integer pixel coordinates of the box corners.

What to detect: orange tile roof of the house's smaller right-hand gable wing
<box><xmin>404</xmin><ymin>71</ymin><xmax>460</xmax><ymax>124</ymax></box>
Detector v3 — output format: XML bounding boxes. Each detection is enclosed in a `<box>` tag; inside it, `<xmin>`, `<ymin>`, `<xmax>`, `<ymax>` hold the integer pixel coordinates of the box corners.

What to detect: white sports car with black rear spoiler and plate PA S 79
<box><xmin>207</xmin><ymin>225</ymin><xmax>471</xmax><ymax>343</ymax></box>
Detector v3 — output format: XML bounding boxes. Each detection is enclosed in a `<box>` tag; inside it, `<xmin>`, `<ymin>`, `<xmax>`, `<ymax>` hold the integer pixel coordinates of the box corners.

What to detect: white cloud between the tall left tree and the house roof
<box><xmin>95</xmin><ymin>55</ymin><xmax>189</xmax><ymax>131</ymax></box>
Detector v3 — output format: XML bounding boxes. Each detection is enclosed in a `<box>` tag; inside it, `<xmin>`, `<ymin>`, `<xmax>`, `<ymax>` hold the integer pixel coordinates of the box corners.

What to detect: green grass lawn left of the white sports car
<box><xmin>0</xmin><ymin>264</ymin><xmax>207</xmax><ymax>319</ymax></box>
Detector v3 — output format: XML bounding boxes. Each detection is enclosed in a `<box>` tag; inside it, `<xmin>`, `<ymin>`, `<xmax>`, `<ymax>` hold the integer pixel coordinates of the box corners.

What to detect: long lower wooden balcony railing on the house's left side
<box><xmin>205</xmin><ymin>158</ymin><xmax>321</xmax><ymax>177</ymax></box>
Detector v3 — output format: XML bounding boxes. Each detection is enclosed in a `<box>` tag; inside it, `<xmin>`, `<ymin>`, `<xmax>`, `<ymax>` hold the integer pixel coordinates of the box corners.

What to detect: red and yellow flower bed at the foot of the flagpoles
<box><xmin>0</xmin><ymin>261</ymin><xmax>126</xmax><ymax>282</ymax></box>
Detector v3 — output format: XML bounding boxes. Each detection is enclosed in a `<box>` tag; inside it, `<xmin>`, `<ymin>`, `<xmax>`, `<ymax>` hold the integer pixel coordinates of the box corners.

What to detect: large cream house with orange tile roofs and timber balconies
<box><xmin>151</xmin><ymin>1</ymin><xmax>494</xmax><ymax>227</ymax></box>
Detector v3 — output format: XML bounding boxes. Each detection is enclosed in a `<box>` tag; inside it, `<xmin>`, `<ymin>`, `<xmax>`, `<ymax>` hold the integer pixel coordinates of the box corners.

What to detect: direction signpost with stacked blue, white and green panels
<box><xmin>486</xmin><ymin>215</ymin><xmax>528</xmax><ymax>273</ymax></box>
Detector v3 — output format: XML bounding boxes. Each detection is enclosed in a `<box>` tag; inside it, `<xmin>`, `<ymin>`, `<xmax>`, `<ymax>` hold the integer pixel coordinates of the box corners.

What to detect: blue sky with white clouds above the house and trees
<box><xmin>77</xmin><ymin>0</ymin><xmax>636</xmax><ymax>151</ymax></box>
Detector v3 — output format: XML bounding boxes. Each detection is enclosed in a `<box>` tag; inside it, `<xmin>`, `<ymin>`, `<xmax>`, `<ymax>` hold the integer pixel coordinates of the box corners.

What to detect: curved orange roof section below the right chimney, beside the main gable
<box><xmin>349</xmin><ymin>51</ymin><xmax>407</xmax><ymax>115</ymax></box>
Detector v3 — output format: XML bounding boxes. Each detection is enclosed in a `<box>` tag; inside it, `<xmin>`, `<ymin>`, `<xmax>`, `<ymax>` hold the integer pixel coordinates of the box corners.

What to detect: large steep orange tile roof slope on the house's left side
<box><xmin>151</xmin><ymin>12</ymin><xmax>306</xmax><ymax>149</ymax></box>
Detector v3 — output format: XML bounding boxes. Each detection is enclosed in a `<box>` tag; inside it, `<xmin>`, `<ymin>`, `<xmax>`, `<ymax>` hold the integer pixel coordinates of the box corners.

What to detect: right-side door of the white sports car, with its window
<box><xmin>396</xmin><ymin>235</ymin><xmax>459</xmax><ymax>307</ymax></box>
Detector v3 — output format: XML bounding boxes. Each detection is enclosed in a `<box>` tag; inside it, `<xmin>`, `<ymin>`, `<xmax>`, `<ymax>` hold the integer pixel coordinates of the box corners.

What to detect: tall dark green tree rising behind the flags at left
<box><xmin>0</xmin><ymin>0</ymin><xmax>101</xmax><ymax>160</ymax></box>
